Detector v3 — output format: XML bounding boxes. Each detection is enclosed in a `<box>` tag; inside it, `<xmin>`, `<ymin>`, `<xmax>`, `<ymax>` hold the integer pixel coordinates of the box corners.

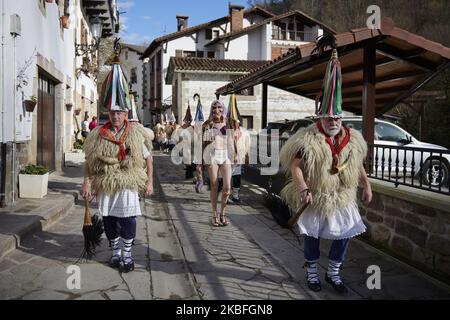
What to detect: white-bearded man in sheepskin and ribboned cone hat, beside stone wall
<box><xmin>280</xmin><ymin>49</ymin><xmax>372</xmax><ymax>294</ymax></box>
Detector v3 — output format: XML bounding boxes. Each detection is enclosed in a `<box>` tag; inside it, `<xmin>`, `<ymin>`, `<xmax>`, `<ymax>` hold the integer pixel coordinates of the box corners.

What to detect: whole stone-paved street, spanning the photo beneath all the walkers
<box><xmin>0</xmin><ymin>152</ymin><xmax>450</xmax><ymax>300</ymax></box>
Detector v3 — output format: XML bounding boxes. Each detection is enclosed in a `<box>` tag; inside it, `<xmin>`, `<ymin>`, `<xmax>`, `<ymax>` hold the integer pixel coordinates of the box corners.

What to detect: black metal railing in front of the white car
<box><xmin>248</xmin><ymin>137</ymin><xmax>450</xmax><ymax>195</ymax></box>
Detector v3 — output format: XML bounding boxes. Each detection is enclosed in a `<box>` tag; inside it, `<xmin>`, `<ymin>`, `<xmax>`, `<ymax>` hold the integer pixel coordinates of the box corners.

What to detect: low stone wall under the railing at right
<box><xmin>359</xmin><ymin>183</ymin><xmax>450</xmax><ymax>282</ymax></box>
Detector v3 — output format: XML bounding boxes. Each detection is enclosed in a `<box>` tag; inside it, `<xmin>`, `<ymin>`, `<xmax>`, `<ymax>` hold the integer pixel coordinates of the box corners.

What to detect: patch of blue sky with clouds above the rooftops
<box><xmin>118</xmin><ymin>0</ymin><xmax>248</xmax><ymax>45</ymax></box>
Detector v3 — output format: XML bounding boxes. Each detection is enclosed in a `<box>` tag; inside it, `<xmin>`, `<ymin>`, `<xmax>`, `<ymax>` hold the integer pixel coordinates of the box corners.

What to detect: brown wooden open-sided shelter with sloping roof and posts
<box><xmin>216</xmin><ymin>19</ymin><xmax>450</xmax><ymax>155</ymax></box>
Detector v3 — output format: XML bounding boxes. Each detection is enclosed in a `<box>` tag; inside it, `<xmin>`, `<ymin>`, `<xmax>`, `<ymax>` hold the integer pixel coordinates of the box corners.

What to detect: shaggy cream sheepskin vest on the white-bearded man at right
<box><xmin>280</xmin><ymin>124</ymin><xmax>367</xmax><ymax>215</ymax></box>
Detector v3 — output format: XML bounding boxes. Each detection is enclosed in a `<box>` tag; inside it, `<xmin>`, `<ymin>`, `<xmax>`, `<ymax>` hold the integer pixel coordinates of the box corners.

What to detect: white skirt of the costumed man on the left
<box><xmin>98</xmin><ymin>189</ymin><xmax>141</xmax><ymax>218</ymax></box>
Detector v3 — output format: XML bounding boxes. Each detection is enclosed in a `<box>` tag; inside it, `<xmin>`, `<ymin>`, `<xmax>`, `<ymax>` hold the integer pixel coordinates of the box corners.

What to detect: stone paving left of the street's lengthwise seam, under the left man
<box><xmin>0</xmin><ymin>164</ymin><xmax>198</xmax><ymax>300</ymax></box>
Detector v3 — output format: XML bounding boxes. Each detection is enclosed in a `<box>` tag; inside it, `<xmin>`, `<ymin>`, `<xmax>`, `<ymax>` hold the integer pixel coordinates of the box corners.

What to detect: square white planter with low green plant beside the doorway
<box><xmin>19</xmin><ymin>164</ymin><xmax>49</xmax><ymax>199</ymax></box>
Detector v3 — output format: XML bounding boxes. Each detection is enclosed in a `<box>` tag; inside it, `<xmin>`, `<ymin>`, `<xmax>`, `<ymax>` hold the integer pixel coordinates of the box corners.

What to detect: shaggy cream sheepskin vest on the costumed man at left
<box><xmin>83</xmin><ymin>124</ymin><xmax>152</xmax><ymax>194</ymax></box>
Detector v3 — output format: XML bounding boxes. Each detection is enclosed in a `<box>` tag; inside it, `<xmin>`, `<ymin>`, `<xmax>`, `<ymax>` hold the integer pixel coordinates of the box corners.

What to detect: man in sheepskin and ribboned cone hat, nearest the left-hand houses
<box><xmin>82</xmin><ymin>53</ymin><xmax>153</xmax><ymax>272</ymax></box>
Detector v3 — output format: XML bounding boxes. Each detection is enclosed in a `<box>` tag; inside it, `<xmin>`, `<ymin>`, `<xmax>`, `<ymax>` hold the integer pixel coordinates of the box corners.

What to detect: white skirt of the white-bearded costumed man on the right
<box><xmin>298</xmin><ymin>202</ymin><xmax>366</xmax><ymax>240</ymax></box>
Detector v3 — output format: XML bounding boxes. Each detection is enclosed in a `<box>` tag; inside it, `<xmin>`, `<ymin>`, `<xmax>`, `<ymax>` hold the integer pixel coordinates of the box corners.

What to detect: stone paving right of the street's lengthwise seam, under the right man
<box><xmin>155</xmin><ymin>155</ymin><xmax>450</xmax><ymax>299</ymax></box>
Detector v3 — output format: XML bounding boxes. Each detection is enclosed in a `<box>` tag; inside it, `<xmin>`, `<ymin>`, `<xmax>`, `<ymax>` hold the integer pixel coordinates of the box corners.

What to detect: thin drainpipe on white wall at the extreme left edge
<box><xmin>0</xmin><ymin>0</ymin><xmax>7</xmax><ymax>207</ymax></box>
